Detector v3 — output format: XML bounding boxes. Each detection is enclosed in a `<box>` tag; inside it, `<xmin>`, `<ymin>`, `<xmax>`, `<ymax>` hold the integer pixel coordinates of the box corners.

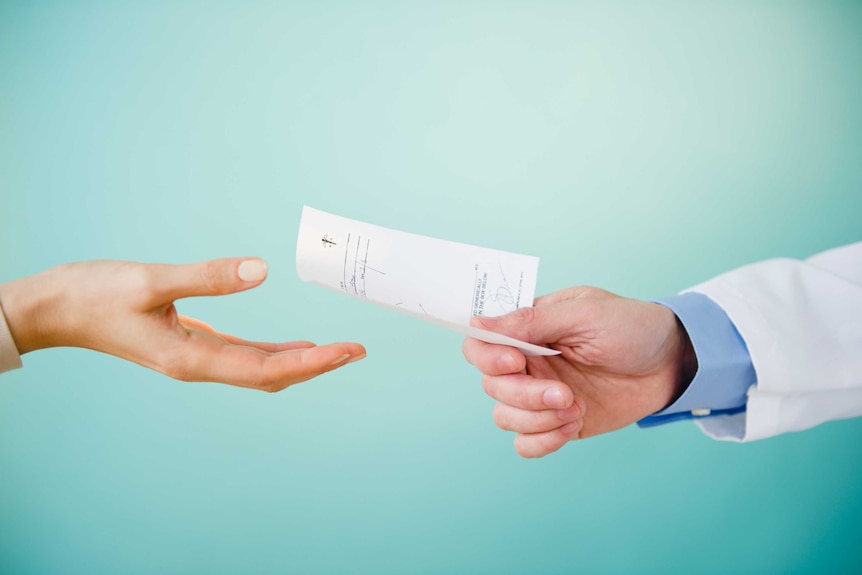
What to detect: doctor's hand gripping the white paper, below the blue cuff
<box><xmin>463</xmin><ymin>287</ymin><xmax>697</xmax><ymax>457</ymax></box>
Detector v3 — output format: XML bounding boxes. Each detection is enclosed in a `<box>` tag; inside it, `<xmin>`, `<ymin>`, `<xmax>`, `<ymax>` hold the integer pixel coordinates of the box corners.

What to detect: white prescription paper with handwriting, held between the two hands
<box><xmin>296</xmin><ymin>206</ymin><xmax>559</xmax><ymax>355</ymax></box>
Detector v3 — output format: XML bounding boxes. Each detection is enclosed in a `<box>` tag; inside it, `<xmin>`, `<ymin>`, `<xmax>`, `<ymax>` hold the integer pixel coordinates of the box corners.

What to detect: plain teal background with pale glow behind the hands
<box><xmin>0</xmin><ymin>1</ymin><xmax>862</xmax><ymax>574</ymax></box>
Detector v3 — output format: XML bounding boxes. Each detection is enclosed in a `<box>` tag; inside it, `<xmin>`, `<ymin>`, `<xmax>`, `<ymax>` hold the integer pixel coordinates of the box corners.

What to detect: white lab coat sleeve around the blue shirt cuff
<box><xmin>686</xmin><ymin>242</ymin><xmax>862</xmax><ymax>441</ymax></box>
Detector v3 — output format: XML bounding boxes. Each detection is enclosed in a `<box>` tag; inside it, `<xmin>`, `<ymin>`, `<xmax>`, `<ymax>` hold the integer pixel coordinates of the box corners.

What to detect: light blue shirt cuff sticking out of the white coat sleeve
<box><xmin>638</xmin><ymin>292</ymin><xmax>757</xmax><ymax>427</ymax></box>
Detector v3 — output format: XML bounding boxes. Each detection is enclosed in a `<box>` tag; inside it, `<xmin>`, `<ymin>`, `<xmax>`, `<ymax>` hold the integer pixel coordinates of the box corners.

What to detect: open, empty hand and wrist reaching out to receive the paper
<box><xmin>0</xmin><ymin>258</ymin><xmax>365</xmax><ymax>392</ymax></box>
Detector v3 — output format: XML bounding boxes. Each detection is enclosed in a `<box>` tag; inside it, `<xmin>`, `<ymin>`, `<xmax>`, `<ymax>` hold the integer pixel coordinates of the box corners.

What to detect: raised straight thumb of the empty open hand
<box><xmin>147</xmin><ymin>258</ymin><xmax>267</xmax><ymax>303</ymax></box>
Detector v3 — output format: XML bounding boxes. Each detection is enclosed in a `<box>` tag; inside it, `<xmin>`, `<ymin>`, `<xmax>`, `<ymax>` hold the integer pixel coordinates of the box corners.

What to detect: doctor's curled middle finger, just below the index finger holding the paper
<box><xmin>482</xmin><ymin>374</ymin><xmax>582</xmax><ymax>410</ymax></box>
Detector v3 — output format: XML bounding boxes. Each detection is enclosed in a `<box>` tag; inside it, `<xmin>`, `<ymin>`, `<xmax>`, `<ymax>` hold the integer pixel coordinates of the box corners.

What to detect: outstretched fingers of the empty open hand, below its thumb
<box><xmin>161</xmin><ymin>331</ymin><xmax>365</xmax><ymax>392</ymax></box>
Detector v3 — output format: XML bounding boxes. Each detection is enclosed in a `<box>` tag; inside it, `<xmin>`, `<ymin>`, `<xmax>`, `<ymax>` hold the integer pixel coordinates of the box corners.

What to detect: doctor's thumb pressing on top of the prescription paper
<box><xmin>470</xmin><ymin>301</ymin><xmax>579</xmax><ymax>344</ymax></box>
